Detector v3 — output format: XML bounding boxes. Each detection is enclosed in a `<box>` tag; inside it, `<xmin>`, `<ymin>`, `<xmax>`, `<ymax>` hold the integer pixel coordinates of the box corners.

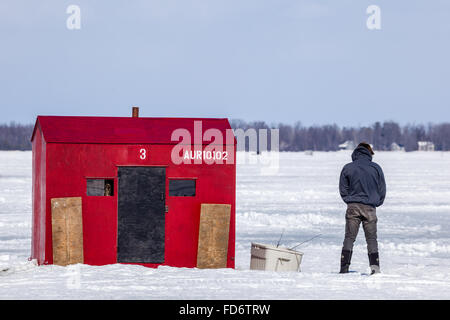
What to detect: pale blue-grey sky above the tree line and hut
<box><xmin>0</xmin><ymin>0</ymin><xmax>450</xmax><ymax>126</ymax></box>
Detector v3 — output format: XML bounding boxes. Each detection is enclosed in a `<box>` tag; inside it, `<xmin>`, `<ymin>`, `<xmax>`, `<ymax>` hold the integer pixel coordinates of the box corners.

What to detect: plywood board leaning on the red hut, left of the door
<box><xmin>51</xmin><ymin>197</ymin><xmax>84</xmax><ymax>266</ymax></box>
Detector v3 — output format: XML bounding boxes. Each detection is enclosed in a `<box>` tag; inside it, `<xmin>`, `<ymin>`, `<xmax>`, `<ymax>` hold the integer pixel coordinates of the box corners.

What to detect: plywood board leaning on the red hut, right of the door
<box><xmin>197</xmin><ymin>203</ymin><xmax>231</xmax><ymax>268</ymax></box>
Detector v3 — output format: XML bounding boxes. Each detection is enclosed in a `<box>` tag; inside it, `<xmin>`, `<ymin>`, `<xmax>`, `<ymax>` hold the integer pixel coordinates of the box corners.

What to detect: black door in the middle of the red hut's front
<box><xmin>117</xmin><ymin>167</ymin><xmax>166</xmax><ymax>263</ymax></box>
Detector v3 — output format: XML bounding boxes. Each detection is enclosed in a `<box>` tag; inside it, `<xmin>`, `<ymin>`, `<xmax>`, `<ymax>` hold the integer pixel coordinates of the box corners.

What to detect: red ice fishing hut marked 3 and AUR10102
<box><xmin>31</xmin><ymin>110</ymin><xmax>236</xmax><ymax>268</ymax></box>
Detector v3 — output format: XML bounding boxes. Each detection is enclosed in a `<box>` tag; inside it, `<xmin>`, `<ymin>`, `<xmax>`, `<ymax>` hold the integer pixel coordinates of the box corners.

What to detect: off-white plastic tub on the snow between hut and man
<box><xmin>250</xmin><ymin>243</ymin><xmax>303</xmax><ymax>272</ymax></box>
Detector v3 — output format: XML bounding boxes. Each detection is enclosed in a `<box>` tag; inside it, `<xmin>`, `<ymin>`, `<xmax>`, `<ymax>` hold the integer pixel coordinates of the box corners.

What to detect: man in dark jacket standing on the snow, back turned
<box><xmin>339</xmin><ymin>142</ymin><xmax>386</xmax><ymax>274</ymax></box>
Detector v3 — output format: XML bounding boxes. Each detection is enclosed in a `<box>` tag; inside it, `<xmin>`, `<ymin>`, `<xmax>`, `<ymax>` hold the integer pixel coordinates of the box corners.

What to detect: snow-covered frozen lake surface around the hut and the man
<box><xmin>0</xmin><ymin>151</ymin><xmax>450</xmax><ymax>299</ymax></box>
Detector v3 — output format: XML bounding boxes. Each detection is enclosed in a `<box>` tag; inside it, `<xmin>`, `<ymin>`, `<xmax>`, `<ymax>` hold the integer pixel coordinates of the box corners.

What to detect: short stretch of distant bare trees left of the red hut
<box><xmin>0</xmin><ymin>122</ymin><xmax>33</xmax><ymax>150</ymax></box>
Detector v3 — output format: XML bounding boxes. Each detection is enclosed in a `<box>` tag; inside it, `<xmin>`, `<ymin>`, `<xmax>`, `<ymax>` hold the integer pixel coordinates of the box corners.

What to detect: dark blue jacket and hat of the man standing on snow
<box><xmin>339</xmin><ymin>147</ymin><xmax>386</xmax><ymax>207</ymax></box>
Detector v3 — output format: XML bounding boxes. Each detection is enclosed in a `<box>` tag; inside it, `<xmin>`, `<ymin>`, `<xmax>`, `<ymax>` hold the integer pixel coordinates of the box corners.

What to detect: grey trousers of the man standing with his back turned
<box><xmin>342</xmin><ymin>203</ymin><xmax>378</xmax><ymax>254</ymax></box>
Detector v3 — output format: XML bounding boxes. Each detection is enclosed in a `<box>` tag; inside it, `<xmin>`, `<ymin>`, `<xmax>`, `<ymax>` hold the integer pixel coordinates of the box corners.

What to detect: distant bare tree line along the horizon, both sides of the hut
<box><xmin>0</xmin><ymin>119</ymin><xmax>450</xmax><ymax>151</ymax></box>
